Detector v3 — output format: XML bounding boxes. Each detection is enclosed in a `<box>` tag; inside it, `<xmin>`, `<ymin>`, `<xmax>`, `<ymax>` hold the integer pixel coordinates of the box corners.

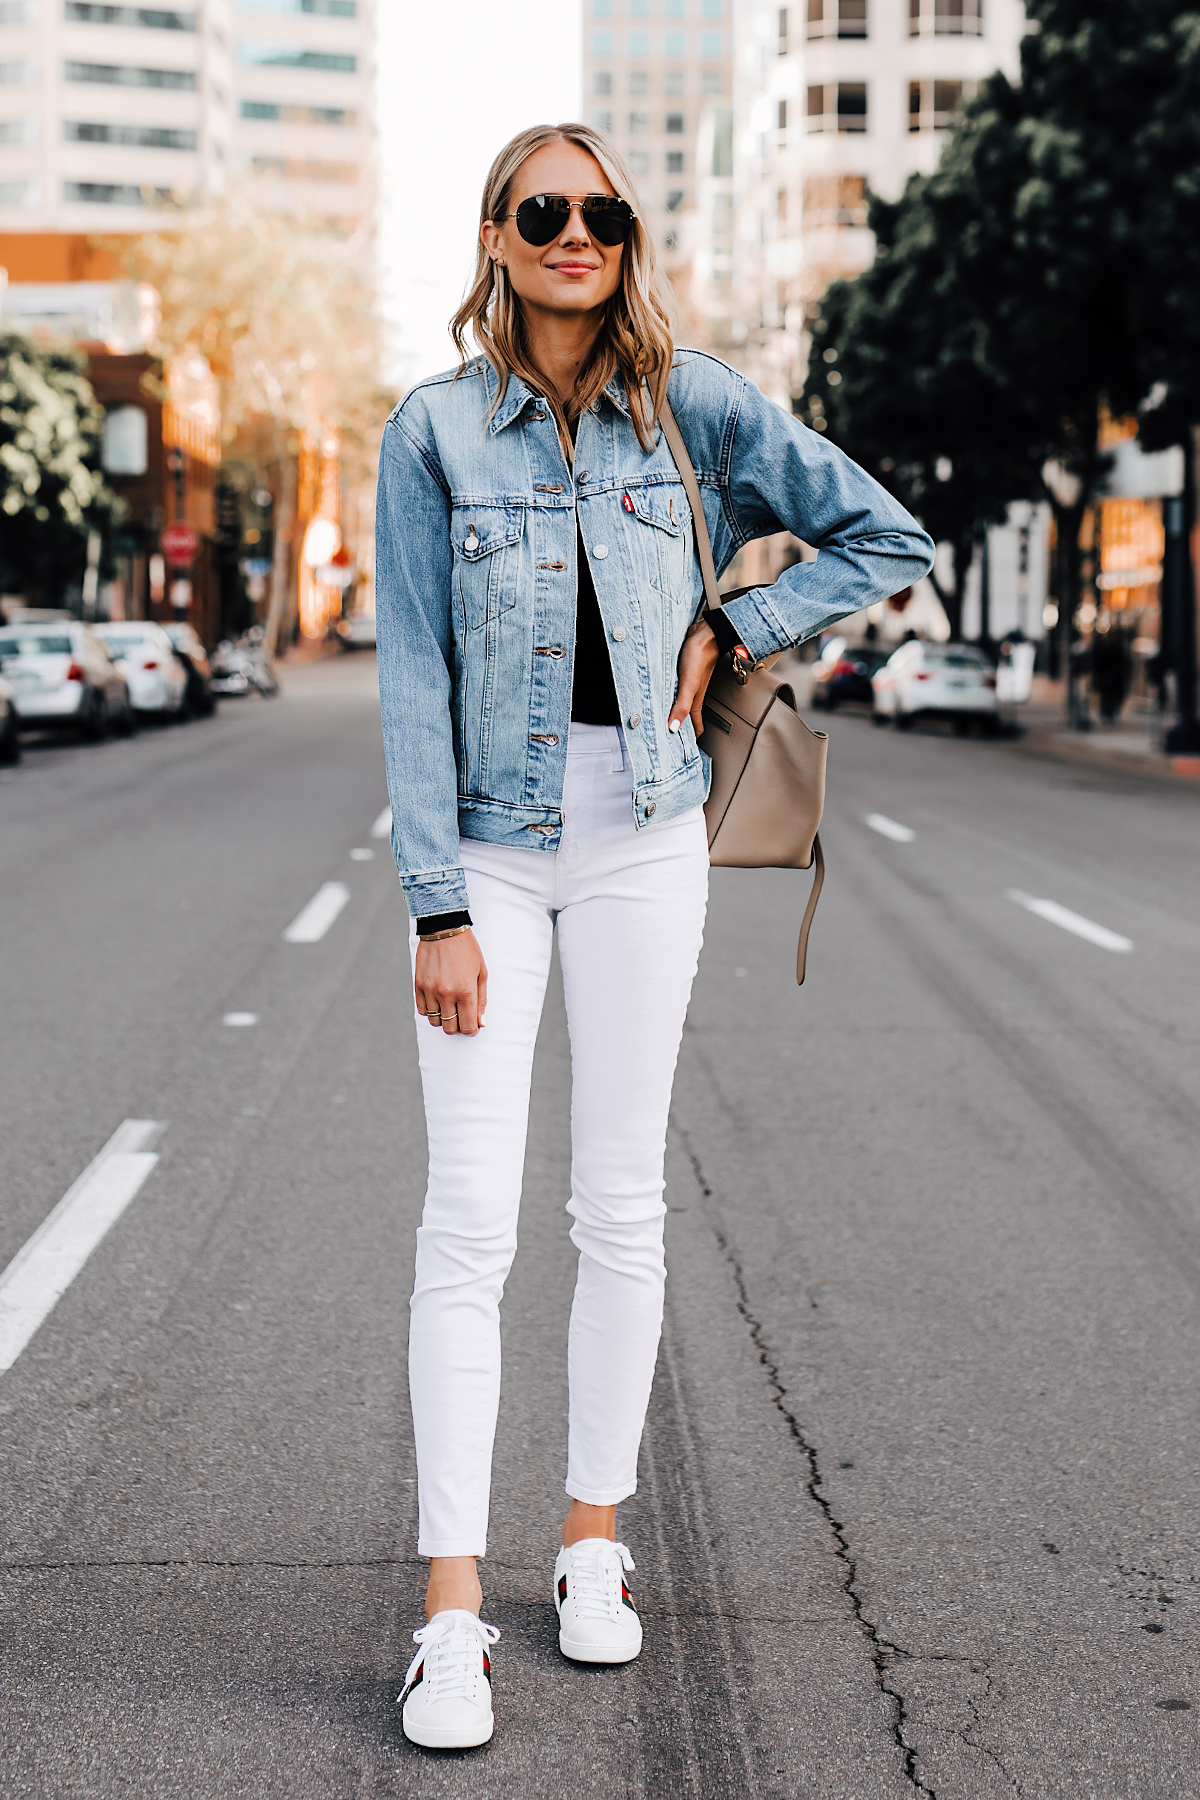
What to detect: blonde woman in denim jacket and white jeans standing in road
<box><xmin>376</xmin><ymin>124</ymin><xmax>932</xmax><ymax>1748</ymax></box>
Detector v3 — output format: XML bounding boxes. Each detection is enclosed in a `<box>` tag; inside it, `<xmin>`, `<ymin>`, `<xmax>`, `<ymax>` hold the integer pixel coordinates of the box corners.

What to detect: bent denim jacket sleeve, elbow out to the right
<box><xmin>723</xmin><ymin>382</ymin><xmax>934</xmax><ymax>657</ymax></box>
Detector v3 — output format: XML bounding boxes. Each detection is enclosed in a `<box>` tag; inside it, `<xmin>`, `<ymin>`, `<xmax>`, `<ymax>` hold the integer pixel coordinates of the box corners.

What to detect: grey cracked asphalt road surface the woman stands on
<box><xmin>0</xmin><ymin>659</ymin><xmax>1200</xmax><ymax>1800</ymax></box>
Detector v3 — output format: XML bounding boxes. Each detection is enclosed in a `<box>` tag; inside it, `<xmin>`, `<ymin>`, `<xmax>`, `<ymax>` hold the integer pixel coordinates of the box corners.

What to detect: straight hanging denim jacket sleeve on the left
<box><xmin>376</xmin><ymin>414</ymin><xmax>468</xmax><ymax>918</ymax></box>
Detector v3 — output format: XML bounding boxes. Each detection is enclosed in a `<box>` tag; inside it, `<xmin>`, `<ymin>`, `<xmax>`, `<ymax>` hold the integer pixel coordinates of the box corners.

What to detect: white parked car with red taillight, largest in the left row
<box><xmin>0</xmin><ymin>619</ymin><xmax>137</xmax><ymax>738</ymax></box>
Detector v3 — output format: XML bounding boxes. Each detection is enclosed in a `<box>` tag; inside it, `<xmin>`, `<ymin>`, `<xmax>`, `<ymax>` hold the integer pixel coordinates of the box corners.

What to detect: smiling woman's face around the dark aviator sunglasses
<box><xmin>480</xmin><ymin>142</ymin><xmax>624</xmax><ymax>325</ymax></box>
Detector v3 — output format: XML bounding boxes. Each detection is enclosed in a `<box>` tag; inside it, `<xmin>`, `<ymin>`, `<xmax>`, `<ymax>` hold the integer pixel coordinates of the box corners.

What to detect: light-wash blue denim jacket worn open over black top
<box><xmin>376</xmin><ymin>349</ymin><xmax>934</xmax><ymax>918</ymax></box>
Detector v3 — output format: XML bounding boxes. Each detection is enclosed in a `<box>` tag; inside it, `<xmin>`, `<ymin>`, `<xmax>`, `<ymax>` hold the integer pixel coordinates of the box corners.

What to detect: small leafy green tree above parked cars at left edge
<box><xmin>0</xmin><ymin>333</ymin><xmax>124</xmax><ymax>607</ymax></box>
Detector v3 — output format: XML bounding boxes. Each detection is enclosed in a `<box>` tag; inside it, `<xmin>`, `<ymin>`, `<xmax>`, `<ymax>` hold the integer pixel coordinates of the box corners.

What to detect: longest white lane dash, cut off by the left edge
<box><xmin>0</xmin><ymin>1120</ymin><xmax>166</xmax><ymax>1373</ymax></box>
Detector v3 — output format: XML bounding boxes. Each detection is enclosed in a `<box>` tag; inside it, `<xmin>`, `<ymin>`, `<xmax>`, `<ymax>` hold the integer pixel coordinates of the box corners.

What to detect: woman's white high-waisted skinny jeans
<box><xmin>408</xmin><ymin>725</ymin><xmax>709</xmax><ymax>1557</ymax></box>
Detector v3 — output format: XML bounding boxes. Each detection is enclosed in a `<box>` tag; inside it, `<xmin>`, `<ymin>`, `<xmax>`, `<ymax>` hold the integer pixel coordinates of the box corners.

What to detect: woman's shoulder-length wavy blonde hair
<box><xmin>450</xmin><ymin>124</ymin><xmax>675</xmax><ymax>461</ymax></box>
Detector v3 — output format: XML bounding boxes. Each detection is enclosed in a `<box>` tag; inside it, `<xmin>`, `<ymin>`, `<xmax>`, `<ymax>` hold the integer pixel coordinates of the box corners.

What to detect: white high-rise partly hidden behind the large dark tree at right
<box><xmin>734</xmin><ymin>0</ymin><xmax>1025</xmax><ymax>401</ymax></box>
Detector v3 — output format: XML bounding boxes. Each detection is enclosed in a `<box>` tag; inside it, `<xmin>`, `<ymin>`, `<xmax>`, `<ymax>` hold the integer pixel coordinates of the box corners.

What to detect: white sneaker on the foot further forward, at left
<box><xmin>398</xmin><ymin>1607</ymin><xmax>500</xmax><ymax>1750</ymax></box>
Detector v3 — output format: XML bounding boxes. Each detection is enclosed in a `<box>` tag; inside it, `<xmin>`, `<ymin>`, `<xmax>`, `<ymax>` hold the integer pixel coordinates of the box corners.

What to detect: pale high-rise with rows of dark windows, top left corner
<box><xmin>0</xmin><ymin>0</ymin><xmax>374</xmax><ymax>234</ymax></box>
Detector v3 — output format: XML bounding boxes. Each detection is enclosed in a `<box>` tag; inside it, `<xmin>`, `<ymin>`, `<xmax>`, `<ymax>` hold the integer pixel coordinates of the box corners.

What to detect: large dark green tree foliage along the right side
<box><xmin>801</xmin><ymin>0</ymin><xmax>1200</xmax><ymax>640</ymax></box>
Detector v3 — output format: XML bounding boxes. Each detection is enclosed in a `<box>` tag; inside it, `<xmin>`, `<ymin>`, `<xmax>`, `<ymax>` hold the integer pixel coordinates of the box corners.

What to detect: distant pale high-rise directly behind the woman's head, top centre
<box><xmin>583</xmin><ymin>0</ymin><xmax>732</xmax><ymax>281</ymax></box>
